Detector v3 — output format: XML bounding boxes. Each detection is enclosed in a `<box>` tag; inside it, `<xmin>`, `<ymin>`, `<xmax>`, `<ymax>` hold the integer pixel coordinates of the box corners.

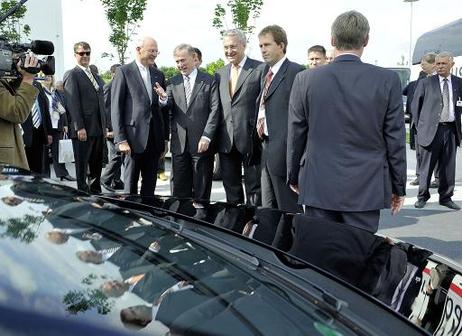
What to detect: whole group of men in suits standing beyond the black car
<box><xmin>9</xmin><ymin>11</ymin><xmax>462</xmax><ymax>232</ymax></box>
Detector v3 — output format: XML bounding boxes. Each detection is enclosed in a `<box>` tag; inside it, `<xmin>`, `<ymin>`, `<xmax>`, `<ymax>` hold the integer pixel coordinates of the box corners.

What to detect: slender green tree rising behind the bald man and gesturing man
<box><xmin>101</xmin><ymin>0</ymin><xmax>147</xmax><ymax>64</ymax></box>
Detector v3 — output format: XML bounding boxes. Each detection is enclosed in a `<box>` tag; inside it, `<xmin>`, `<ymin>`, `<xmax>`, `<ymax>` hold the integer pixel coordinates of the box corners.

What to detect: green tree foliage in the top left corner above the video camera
<box><xmin>0</xmin><ymin>0</ymin><xmax>31</xmax><ymax>43</ymax></box>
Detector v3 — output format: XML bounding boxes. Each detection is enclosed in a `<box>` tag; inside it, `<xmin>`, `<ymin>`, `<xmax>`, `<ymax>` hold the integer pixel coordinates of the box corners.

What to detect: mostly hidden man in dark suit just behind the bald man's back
<box><xmin>101</xmin><ymin>64</ymin><xmax>124</xmax><ymax>191</ymax></box>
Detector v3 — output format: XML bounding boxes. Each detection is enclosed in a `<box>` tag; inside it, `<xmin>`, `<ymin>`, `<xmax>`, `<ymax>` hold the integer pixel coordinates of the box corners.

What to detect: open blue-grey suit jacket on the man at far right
<box><xmin>411</xmin><ymin>75</ymin><xmax>462</xmax><ymax>146</ymax></box>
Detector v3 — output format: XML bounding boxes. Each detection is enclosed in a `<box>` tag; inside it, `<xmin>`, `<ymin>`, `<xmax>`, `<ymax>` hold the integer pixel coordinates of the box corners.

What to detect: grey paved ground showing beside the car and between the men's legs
<box><xmin>52</xmin><ymin>143</ymin><xmax>462</xmax><ymax>265</ymax></box>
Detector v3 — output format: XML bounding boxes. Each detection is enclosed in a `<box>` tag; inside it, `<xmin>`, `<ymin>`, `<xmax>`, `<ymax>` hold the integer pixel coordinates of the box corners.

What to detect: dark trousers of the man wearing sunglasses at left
<box><xmin>72</xmin><ymin>135</ymin><xmax>104</xmax><ymax>193</ymax></box>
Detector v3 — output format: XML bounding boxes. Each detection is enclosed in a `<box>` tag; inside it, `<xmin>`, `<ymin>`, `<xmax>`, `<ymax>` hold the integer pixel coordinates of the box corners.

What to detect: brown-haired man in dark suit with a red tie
<box><xmin>257</xmin><ymin>25</ymin><xmax>303</xmax><ymax>212</ymax></box>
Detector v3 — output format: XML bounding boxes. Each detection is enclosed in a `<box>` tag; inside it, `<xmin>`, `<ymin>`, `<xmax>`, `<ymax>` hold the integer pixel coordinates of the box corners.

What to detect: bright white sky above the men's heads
<box><xmin>19</xmin><ymin>0</ymin><xmax>461</xmax><ymax>75</ymax></box>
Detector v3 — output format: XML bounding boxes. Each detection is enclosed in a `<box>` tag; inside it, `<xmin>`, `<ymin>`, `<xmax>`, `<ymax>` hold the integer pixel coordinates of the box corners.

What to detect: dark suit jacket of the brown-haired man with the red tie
<box><xmin>254</xmin><ymin>59</ymin><xmax>303</xmax><ymax>178</ymax></box>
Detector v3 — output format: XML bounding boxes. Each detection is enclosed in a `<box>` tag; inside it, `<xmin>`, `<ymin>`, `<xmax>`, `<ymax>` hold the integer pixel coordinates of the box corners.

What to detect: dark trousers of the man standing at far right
<box><xmin>417</xmin><ymin>122</ymin><xmax>457</xmax><ymax>202</ymax></box>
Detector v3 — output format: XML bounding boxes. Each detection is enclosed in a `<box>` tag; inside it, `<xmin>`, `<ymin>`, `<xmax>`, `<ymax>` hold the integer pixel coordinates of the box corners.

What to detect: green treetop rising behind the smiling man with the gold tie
<box><xmin>212</xmin><ymin>0</ymin><xmax>263</xmax><ymax>38</ymax></box>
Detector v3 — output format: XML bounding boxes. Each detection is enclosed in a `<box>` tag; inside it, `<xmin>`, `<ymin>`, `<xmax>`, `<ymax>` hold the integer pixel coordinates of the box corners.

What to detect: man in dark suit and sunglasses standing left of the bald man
<box><xmin>64</xmin><ymin>42</ymin><xmax>107</xmax><ymax>194</ymax></box>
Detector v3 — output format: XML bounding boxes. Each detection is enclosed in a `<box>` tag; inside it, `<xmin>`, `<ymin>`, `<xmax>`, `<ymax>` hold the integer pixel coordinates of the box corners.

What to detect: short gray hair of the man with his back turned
<box><xmin>331</xmin><ymin>11</ymin><xmax>370</xmax><ymax>50</ymax></box>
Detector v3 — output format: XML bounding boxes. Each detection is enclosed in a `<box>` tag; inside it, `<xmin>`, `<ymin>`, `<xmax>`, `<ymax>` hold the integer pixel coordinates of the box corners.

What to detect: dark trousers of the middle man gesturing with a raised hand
<box><xmin>172</xmin><ymin>146</ymin><xmax>213</xmax><ymax>202</ymax></box>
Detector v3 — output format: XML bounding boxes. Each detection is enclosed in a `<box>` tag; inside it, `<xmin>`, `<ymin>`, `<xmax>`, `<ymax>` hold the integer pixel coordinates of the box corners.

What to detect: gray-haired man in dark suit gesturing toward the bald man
<box><xmin>159</xmin><ymin>44</ymin><xmax>220</xmax><ymax>209</ymax></box>
